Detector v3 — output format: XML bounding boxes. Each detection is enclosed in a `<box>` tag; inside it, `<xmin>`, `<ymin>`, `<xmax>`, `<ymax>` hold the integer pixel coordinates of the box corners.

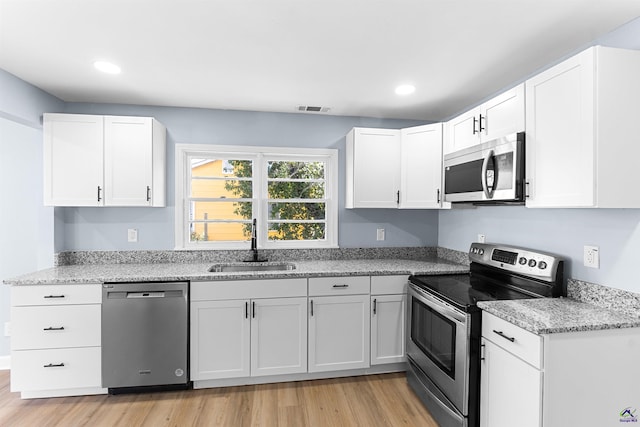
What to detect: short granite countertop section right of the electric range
<box><xmin>478</xmin><ymin>298</ymin><xmax>640</xmax><ymax>335</ymax></box>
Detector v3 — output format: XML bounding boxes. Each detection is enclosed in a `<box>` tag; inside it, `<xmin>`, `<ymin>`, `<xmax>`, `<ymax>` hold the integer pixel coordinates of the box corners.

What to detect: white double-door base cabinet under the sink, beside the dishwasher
<box><xmin>191</xmin><ymin>279</ymin><xmax>307</xmax><ymax>381</ymax></box>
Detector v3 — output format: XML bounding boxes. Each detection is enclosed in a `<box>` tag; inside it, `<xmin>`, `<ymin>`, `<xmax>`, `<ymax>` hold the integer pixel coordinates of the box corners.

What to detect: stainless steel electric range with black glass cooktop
<box><xmin>407</xmin><ymin>243</ymin><xmax>566</xmax><ymax>427</ymax></box>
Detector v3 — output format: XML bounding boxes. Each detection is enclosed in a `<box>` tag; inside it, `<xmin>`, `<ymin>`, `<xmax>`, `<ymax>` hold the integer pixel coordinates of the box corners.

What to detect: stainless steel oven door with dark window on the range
<box><xmin>407</xmin><ymin>284</ymin><xmax>471</xmax><ymax>416</ymax></box>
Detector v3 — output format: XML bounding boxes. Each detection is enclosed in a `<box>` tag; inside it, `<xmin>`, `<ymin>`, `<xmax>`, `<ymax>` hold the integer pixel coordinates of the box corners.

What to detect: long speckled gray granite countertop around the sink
<box><xmin>4</xmin><ymin>258</ymin><xmax>469</xmax><ymax>285</ymax></box>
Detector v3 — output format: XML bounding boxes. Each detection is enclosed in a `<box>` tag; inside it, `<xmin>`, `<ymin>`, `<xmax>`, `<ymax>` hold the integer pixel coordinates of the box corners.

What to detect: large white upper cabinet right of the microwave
<box><xmin>526</xmin><ymin>46</ymin><xmax>640</xmax><ymax>208</ymax></box>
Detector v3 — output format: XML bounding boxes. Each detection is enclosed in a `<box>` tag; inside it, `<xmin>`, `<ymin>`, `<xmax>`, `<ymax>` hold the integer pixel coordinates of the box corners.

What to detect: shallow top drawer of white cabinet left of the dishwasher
<box><xmin>11</xmin><ymin>283</ymin><xmax>102</xmax><ymax>306</ymax></box>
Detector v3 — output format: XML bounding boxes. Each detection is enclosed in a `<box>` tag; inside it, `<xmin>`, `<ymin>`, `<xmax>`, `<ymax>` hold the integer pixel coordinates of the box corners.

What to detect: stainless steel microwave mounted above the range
<box><xmin>444</xmin><ymin>132</ymin><xmax>524</xmax><ymax>204</ymax></box>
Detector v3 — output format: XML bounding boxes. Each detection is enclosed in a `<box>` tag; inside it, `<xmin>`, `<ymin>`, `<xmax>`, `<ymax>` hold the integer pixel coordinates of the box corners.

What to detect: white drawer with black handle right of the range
<box><xmin>482</xmin><ymin>312</ymin><xmax>542</xmax><ymax>369</ymax></box>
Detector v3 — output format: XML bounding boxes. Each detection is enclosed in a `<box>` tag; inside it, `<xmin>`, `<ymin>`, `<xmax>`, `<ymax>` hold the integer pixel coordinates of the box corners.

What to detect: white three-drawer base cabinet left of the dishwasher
<box><xmin>11</xmin><ymin>284</ymin><xmax>106</xmax><ymax>398</ymax></box>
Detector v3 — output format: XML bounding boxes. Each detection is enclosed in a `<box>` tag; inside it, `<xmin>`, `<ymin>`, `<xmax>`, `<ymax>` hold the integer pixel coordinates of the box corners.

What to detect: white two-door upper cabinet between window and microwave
<box><xmin>345</xmin><ymin>123</ymin><xmax>442</xmax><ymax>209</ymax></box>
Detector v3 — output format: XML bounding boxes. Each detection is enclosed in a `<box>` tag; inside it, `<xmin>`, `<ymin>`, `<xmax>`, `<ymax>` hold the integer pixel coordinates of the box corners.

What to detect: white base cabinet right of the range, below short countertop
<box><xmin>480</xmin><ymin>312</ymin><xmax>640</xmax><ymax>427</ymax></box>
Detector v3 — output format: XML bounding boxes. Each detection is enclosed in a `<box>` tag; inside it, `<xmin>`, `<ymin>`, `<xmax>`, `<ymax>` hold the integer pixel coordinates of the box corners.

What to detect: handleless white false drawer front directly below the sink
<box><xmin>191</xmin><ymin>279</ymin><xmax>307</xmax><ymax>301</ymax></box>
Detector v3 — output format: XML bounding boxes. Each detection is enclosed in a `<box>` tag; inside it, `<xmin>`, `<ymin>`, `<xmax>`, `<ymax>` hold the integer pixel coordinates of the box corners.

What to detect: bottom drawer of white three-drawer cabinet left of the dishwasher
<box><xmin>11</xmin><ymin>347</ymin><xmax>102</xmax><ymax>391</ymax></box>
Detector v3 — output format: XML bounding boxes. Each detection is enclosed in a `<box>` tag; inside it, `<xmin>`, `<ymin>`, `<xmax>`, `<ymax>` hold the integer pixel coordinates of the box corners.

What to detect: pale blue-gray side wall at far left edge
<box><xmin>0</xmin><ymin>70</ymin><xmax>63</xmax><ymax>365</ymax></box>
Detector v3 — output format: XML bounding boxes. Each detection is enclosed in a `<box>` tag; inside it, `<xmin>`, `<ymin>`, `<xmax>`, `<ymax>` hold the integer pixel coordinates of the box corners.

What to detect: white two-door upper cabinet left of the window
<box><xmin>43</xmin><ymin>114</ymin><xmax>166</xmax><ymax>206</ymax></box>
